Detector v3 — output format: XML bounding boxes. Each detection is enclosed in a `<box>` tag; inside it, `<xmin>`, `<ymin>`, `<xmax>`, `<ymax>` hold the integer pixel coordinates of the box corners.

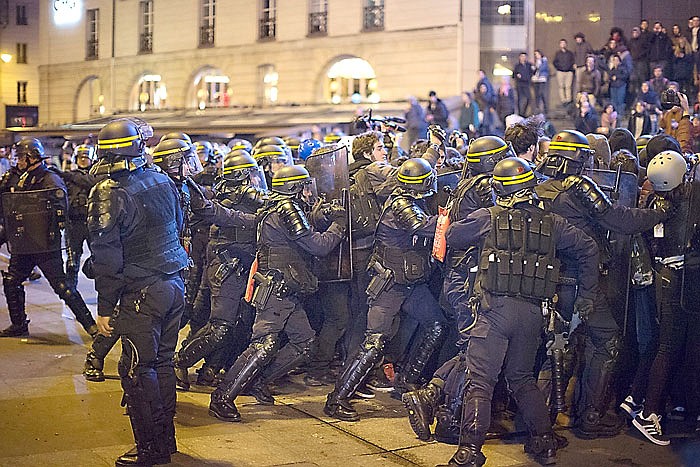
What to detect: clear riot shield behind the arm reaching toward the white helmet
<box><xmin>584</xmin><ymin>169</ymin><xmax>638</xmax><ymax>325</ymax></box>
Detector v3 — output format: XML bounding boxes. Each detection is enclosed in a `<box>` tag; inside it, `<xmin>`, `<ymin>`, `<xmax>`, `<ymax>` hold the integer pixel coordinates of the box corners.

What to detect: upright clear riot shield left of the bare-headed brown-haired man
<box><xmin>305</xmin><ymin>146</ymin><xmax>352</xmax><ymax>282</ymax></box>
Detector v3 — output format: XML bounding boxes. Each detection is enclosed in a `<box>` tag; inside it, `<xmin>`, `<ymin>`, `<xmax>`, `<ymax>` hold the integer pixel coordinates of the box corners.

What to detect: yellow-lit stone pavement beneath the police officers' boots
<box><xmin>0</xmin><ymin>262</ymin><xmax>700</xmax><ymax>467</ymax></box>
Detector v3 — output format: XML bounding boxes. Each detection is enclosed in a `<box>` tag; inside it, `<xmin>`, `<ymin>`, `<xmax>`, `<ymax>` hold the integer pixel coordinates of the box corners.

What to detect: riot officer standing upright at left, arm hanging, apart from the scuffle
<box><xmin>88</xmin><ymin>119</ymin><xmax>188</xmax><ymax>465</ymax></box>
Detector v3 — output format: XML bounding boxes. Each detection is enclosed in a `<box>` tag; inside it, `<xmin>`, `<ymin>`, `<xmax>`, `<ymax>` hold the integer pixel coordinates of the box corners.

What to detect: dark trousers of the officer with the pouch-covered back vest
<box><xmin>460</xmin><ymin>297</ymin><xmax>552</xmax><ymax>447</ymax></box>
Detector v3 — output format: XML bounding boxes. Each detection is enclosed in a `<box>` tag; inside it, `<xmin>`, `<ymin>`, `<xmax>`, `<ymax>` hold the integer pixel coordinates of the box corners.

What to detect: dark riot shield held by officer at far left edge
<box><xmin>2</xmin><ymin>188</ymin><xmax>68</xmax><ymax>254</ymax></box>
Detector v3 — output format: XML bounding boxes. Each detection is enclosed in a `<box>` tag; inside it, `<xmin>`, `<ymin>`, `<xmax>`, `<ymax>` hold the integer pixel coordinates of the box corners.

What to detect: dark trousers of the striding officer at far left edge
<box><xmin>3</xmin><ymin>251</ymin><xmax>95</xmax><ymax>330</ymax></box>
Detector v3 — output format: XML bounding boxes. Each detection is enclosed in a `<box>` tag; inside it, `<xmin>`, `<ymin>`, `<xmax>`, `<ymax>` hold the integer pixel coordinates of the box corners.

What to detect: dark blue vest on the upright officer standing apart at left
<box><xmin>120</xmin><ymin>170</ymin><xmax>188</xmax><ymax>274</ymax></box>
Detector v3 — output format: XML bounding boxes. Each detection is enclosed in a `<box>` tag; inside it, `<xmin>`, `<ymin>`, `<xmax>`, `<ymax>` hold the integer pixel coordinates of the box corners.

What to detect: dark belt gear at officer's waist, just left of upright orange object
<box><xmin>370</xmin><ymin>245</ymin><xmax>431</xmax><ymax>285</ymax></box>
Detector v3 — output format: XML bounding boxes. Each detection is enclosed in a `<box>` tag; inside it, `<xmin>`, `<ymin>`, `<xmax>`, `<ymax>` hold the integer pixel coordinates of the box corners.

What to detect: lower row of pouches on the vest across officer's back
<box><xmin>479</xmin><ymin>249</ymin><xmax>561</xmax><ymax>303</ymax></box>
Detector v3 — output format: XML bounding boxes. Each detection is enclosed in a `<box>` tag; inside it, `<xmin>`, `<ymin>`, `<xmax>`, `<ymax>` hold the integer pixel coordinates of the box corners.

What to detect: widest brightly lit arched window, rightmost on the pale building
<box><xmin>317</xmin><ymin>55</ymin><xmax>380</xmax><ymax>104</ymax></box>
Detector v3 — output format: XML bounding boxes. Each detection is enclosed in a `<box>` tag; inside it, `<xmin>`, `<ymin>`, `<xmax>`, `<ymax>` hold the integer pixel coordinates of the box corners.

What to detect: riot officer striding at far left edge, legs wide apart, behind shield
<box><xmin>0</xmin><ymin>138</ymin><xmax>97</xmax><ymax>337</ymax></box>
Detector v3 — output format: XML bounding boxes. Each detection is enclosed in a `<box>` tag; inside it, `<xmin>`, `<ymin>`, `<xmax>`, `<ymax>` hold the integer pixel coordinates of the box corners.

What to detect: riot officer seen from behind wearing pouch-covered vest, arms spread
<box><xmin>447</xmin><ymin>157</ymin><xmax>598</xmax><ymax>466</ymax></box>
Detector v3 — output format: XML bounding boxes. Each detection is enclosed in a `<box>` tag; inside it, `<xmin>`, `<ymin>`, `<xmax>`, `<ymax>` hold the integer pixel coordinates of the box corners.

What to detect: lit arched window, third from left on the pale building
<box><xmin>185</xmin><ymin>65</ymin><xmax>231</xmax><ymax>110</ymax></box>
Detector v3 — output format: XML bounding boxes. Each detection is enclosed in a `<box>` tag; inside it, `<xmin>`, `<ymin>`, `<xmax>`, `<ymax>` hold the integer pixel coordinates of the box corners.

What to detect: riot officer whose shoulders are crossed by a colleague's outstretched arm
<box><xmin>175</xmin><ymin>150</ymin><xmax>265</xmax><ymax>390</ymax></box>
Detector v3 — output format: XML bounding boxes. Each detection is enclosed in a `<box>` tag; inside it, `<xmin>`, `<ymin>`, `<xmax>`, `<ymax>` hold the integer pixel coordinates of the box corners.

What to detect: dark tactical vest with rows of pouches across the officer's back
<box><xmin>478</xmin><ymin>206</ymin><xmax>560</xmax><ymax>300</ymax></box>
